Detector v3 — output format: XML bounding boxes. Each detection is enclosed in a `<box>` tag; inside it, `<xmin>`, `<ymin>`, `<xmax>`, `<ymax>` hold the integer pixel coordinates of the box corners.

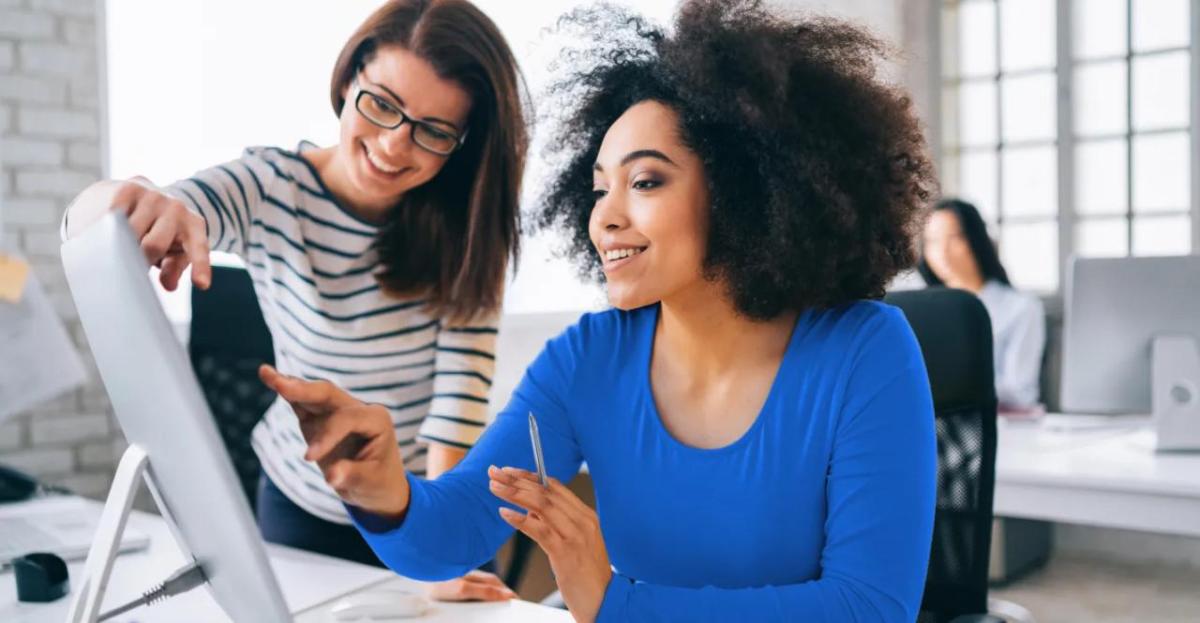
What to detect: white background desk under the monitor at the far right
<box><xmin>995</xmin><ymin>417</ymin><xmax>1200</xmax><ymax>537</ymax></box>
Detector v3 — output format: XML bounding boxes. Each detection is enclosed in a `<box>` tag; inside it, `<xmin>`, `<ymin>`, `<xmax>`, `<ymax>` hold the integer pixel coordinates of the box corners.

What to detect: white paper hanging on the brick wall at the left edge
<box><xmin>0</xmin><ymin>272</ymin><xmax>86</xmax><ymax>420</ymax></box>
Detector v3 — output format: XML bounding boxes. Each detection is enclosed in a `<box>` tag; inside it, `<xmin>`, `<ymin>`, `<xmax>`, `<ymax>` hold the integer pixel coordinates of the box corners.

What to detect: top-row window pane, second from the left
<box><xmin>1000</xmin><ymin>0</ymin><xmax>1055</xmax><ymax>71</ymax></box>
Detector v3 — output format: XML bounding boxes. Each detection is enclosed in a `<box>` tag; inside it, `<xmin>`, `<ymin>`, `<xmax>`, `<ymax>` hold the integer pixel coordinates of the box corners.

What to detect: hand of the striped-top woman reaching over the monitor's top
<box><xmin>66</xmin><ymin>178</ymin><xmax>212</xmax><ymax>290</ymax></box>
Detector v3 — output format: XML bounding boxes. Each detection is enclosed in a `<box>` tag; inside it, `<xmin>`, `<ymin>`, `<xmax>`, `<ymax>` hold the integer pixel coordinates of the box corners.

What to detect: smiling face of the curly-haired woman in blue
<box><xmin>588</xmin><ymin>101</ymin><xmax>712</xmax><ymax>310</ymax></box>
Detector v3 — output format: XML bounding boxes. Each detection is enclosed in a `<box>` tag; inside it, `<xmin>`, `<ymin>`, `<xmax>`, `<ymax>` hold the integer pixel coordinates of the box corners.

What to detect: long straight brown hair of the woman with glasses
<box><xmin>330</xmin><ymin>0</ymin><xmax>528</xmax><ymax>321</ymax></box>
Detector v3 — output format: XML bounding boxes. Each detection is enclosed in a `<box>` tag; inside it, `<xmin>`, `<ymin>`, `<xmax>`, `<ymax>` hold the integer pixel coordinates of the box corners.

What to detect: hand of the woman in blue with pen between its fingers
<box><xmin>487</xmin><ymin>466</ymin><xmax>612</xmax><ymax>623</ymax></box>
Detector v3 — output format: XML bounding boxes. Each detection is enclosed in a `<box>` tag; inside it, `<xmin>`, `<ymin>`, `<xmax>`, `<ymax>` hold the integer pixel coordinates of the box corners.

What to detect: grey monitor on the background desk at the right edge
<box><xmin>1061</xmin><ymin>256</ymin><xmax>1200</xmax><ymax>444</ymax></box>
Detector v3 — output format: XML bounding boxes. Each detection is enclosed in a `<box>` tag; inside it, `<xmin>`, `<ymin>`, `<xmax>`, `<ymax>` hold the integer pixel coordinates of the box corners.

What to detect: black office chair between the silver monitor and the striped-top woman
<box><xmin>187</xmin><ymin>266</ymin><xmax>275</xmax><ymax>509</ymax></box>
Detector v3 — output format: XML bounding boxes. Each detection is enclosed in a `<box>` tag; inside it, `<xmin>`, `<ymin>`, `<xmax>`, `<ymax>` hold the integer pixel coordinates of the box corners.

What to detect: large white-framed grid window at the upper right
<box><xmin>941</xmin><ymin>0</ymin><xmax>1200</xmax><ymax>293</ymax></box>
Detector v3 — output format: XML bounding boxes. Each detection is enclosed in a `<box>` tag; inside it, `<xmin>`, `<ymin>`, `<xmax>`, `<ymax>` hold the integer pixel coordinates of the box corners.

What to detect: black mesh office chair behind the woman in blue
<box><xmin>884</xmin><ymin>288</ymin><xmax>1000</xmax><ymax>623</ymax></box>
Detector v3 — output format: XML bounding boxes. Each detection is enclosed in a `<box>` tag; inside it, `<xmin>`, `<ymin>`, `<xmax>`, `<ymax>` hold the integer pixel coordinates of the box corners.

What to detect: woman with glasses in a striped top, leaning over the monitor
<box><xmin>64</xmin><ymin>0</ymin><xmax>527</xmax><ymax>599</ymax></box>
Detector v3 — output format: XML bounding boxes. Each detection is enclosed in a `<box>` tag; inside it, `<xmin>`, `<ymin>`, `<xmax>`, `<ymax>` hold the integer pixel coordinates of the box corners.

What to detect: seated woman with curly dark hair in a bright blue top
<box><xmin>263</xmin><ymin>0</ymin><xmax>936</xmax><ymax>622</ymax></box>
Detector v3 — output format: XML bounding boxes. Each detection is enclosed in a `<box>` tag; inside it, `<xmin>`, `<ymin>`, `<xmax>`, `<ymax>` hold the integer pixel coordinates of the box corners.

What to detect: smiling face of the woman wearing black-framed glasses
<box><xmin>337</xmin><ymin>47</ymin><xmax>472</xmax><ymax>213</ymax></box>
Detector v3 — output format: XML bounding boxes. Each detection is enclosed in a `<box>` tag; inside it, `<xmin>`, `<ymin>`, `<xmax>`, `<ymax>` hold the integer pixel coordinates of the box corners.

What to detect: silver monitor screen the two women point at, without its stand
<box><xmin>62</xmin><ymin>212</ymin><xmax>290</xmax><ymax>622</ymax></box>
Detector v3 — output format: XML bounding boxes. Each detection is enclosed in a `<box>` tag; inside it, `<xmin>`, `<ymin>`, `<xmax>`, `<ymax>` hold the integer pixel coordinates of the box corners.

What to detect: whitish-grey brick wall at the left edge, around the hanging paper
<box><xmin>0</xmin><ymin>0</ymin><xmax>124</xmax><ymax>497</ymax></box>
